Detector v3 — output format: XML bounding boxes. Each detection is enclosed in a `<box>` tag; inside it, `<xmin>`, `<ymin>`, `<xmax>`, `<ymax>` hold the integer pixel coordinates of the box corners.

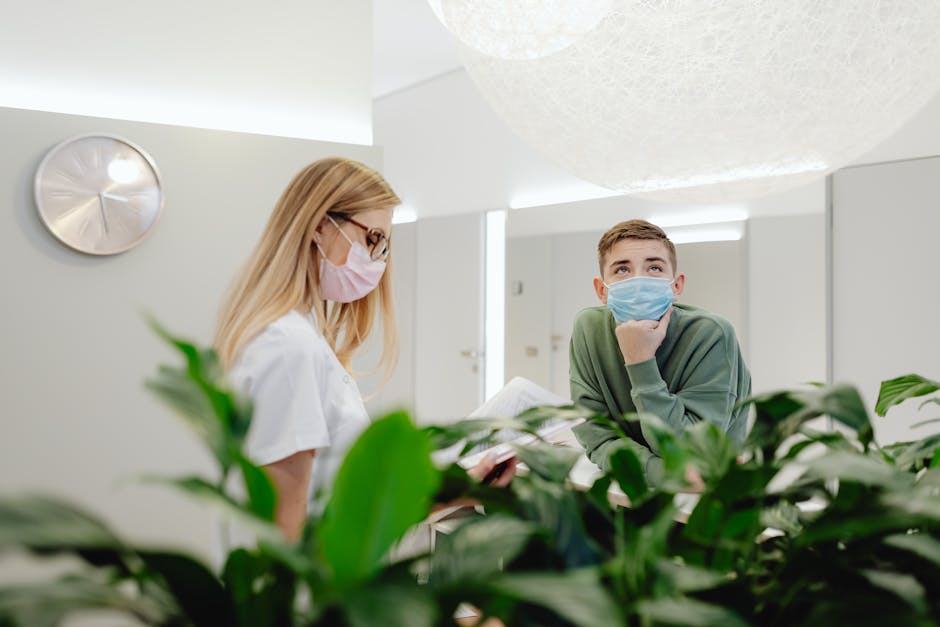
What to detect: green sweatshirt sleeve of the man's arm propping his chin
<box><xmin>627</xmin><ymin>326</ymin><xmax>738</xmax><ymax>448</ymax></box>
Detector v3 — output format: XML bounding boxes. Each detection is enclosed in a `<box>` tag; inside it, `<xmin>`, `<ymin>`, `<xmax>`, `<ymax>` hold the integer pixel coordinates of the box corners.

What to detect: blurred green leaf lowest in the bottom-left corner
<box><xmin>0</xmin><ymin>575</ymin><xmax>171</xmax><ymax>627</ymax></box>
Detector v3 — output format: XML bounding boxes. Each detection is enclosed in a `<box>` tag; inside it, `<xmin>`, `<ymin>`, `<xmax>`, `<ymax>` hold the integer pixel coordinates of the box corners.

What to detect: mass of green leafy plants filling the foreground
<box><xmin>0</xmin><ymin>331</ymin><xmax>940</xmax><ymax>626</ymax></box>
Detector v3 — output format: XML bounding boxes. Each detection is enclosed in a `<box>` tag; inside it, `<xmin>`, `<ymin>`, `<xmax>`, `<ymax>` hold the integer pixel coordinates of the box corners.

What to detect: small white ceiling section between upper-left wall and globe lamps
<box><xmin>372</xmin><ymin>0</ymin><xmax>461</xmax><ymax>98</ymax></box>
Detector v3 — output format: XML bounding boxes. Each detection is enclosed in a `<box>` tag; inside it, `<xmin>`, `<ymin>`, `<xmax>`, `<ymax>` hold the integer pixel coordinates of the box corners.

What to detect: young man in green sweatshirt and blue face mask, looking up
<box><xmin>570</xmin><ymin>220</ymin><xmax>751</xmax><ymax>484</ymax></box>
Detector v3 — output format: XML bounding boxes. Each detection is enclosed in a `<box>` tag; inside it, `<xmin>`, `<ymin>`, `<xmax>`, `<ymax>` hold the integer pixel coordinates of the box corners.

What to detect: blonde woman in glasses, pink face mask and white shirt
<box><xmin>214</xmin><ymin>158</ymin><xmax>512</xmax><ymax>540</ymax></box>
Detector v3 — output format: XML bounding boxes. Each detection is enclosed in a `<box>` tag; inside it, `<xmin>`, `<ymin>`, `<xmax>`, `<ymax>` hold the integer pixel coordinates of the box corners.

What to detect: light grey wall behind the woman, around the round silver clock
<box><xmin>0</xmin><ymin>109</ymin><xmax>381</xmax><ymax>554</ymax></box>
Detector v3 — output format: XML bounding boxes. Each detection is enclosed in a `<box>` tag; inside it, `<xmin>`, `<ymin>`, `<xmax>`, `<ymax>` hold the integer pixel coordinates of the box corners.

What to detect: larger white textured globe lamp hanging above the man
<box><xmin>432</xmin><ymin>0</ymin><xmax>940</xmax><ymax>202</ymax></box>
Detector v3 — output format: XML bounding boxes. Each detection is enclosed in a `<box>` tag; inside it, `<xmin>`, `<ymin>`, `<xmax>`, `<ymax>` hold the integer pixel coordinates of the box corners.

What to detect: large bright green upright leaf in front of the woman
<box><xmin>318</xmin><ymin>413</ymin><xmax>440</xmax><ymax>586</ymax></box>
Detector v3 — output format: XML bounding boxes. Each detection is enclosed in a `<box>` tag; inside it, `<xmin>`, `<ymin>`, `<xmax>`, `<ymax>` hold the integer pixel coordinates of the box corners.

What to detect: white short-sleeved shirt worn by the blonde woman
<box><xmin>229</xmin><ymin>311</ymin><xmax>369</xmax><ymax>505</ymax></box>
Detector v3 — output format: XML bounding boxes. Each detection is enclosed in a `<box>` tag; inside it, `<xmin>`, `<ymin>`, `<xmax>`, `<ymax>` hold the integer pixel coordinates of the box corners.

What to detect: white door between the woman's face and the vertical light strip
<box><xmin>414</xmin><ymin>214</ymin><xmax>485</xmax><ymax>424</ymax></box>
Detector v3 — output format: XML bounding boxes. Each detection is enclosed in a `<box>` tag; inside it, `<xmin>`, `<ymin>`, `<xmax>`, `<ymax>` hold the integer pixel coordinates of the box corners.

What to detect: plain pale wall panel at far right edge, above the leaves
<box><xmin>832</xmin><ymin>157</ymin><xmax>940</xmax><ymax>443</ymax></box>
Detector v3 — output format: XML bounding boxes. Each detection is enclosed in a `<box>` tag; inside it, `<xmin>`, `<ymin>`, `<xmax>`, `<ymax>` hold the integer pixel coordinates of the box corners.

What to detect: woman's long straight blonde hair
<box><xmin>213</xmin><ymin>157</ymin><xmax>401</xmax><ymax>380</ymax></box>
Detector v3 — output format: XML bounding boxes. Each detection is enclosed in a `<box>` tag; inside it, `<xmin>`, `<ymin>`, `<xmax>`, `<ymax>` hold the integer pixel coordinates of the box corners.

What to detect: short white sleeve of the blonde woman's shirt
<box><xmin>245</xmin><ymin>336</ymin><xmax>330</xmax><ymax>465</ymax></box>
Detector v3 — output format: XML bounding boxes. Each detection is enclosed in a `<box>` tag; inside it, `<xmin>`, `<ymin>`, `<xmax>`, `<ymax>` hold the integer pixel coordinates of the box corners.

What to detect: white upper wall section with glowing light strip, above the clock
<box><xmin>0</xmin><ymin>0</ymin><xmax>372</xmax><ymax>144</ymax></box>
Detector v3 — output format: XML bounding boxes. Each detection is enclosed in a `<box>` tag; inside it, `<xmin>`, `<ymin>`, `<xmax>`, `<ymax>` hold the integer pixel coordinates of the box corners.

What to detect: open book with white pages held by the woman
<box><xmin>459</xmin><ymin>377</ymin><xmax>583</xmax><ymax>468</ymax></box>
